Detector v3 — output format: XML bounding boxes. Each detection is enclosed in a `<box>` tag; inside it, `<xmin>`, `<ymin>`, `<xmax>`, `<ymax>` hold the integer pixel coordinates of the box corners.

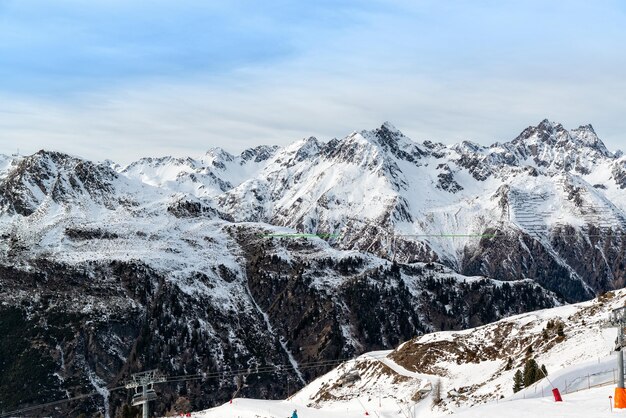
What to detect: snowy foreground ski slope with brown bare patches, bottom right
<box><xmin>191</xmin><ymin>290</ymin><xmax>626</xmax><ymax>418</ymax></box>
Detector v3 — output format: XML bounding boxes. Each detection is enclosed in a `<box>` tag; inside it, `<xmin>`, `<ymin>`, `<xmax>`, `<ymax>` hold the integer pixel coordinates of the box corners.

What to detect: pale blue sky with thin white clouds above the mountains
<box><xmin>0</xmin><ymin>0</ymin><xmax>626</xmax><ymax>164</ymax></box>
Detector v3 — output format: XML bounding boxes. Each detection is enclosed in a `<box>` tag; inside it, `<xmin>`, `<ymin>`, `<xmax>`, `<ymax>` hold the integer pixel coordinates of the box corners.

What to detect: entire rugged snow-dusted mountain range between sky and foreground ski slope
<box><xmin>0</xmin><ymin>121</ymin><xmax>626</xmax><ymax>416</ymax></box>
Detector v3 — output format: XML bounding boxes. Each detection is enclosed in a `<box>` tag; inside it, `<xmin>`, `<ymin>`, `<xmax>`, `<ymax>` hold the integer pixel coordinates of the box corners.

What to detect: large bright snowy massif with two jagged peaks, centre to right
<box><xmin>212</xmin><ymin>121</ymin><xmax>626</xmax><ymax>300</ymax></box>
